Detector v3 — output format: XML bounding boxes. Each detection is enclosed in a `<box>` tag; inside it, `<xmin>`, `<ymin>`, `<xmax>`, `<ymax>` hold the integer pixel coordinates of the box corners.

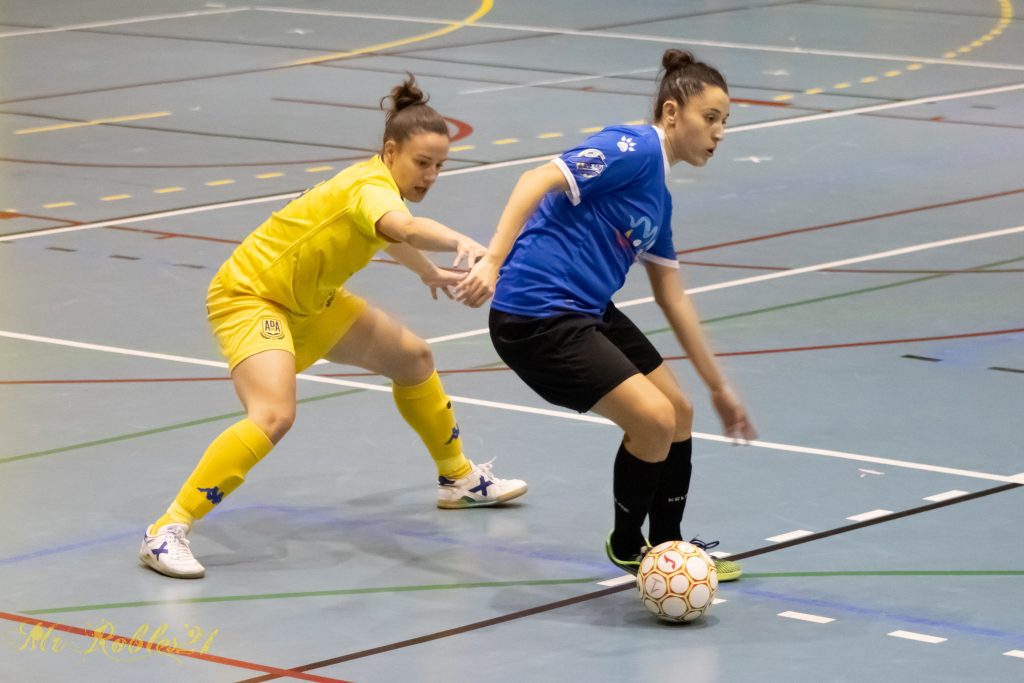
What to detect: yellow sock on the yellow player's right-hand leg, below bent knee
<box><xmin>392</xmin><ymin>371</ymin><xmax>473</xmax><ymax>479</ymax></box>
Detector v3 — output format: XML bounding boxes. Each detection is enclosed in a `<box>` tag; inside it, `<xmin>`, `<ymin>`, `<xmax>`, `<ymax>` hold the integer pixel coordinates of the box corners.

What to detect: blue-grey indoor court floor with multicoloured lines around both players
<box><xmin>0</xmin><ymin>0</ymin><xmax>1024</xmax><ymax>683</ymax></box>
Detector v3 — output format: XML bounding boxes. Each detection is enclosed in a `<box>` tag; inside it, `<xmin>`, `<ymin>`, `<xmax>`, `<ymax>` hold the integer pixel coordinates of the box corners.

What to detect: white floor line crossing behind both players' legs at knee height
<box><xmin>0</xmin><ymin>330</ymin><xmax>1024</xmax><ymax>483</ymax></box>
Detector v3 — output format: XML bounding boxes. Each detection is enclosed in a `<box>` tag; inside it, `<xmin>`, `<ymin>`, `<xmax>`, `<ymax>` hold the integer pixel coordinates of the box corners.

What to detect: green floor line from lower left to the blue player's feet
<box><xmin>18</xmin><ymin>578</ymin><xmax>599</xmax><ymax>616</ymax></box>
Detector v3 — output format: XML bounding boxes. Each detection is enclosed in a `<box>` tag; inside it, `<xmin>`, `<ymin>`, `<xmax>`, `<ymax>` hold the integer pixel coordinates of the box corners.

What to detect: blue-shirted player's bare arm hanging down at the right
<box><xmin>644</xmin><ymin>262</ymin><xmax>758</xmax><ymax>441</ymax></box>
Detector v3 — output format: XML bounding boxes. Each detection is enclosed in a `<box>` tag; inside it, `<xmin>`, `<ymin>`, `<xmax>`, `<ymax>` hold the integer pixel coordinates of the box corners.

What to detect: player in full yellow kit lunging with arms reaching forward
<box><xmin>139</xmin><ymin>76</ymin><xmax>526</xmax><ymax>579</ymax></box>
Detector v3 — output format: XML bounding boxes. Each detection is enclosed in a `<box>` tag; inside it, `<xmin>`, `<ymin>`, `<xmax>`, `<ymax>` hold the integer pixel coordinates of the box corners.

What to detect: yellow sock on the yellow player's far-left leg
<box><xmin>151</xmin><ymin>419</ymin><xmax>273</xmax><ymax>531</ymax></box>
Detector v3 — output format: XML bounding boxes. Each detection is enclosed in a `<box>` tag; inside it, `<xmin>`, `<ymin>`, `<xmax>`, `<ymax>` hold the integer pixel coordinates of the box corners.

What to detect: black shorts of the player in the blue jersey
<box><xmin>489</xmin><ymin>303</ymin><xmax>664</xmax><ymax>413</ymax></box>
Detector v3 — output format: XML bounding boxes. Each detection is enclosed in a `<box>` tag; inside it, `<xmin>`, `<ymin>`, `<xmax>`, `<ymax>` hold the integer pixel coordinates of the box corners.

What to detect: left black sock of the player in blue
<box><xmin>611</xmin><ymin>443</ymin><xmax>664</xmax><ymax>559</ymax></box>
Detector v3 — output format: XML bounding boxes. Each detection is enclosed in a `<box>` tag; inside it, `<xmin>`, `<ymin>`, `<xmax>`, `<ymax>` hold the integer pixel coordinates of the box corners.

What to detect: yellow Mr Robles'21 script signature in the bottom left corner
<box><xmin>17</xmin><ymin>620</ymin><xmax>220</xmax><ymax>661</ymax></box>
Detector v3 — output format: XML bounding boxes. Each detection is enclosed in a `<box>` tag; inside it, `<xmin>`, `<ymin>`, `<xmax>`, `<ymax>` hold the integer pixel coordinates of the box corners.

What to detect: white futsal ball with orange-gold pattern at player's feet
<box><xmin>637</xmin><ymin>541</ymin><xmax>718</xmax><ymax>622</ymax></box>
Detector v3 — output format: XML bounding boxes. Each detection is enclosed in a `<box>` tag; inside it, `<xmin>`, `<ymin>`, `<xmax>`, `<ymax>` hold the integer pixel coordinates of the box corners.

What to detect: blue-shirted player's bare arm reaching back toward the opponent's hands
<box><xmin>455</xmin><ymin>162</ymin><xmax>569</xmax><ymax>308</ymax></box>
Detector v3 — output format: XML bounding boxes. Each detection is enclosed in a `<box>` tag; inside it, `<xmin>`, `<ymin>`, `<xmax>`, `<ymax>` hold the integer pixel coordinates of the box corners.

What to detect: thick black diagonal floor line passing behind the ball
<box><xmin>238</xmin><ymin>483</ymin><xmax>1024</xmax><ymax>683</ymax></box>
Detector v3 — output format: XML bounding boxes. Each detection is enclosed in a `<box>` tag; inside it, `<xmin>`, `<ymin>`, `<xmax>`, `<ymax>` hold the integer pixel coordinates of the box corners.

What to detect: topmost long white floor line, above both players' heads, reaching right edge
<box><xmin>253</xmin><ymin>7</ymin><xmax>1024</xmax><ymax>71</ymax></box>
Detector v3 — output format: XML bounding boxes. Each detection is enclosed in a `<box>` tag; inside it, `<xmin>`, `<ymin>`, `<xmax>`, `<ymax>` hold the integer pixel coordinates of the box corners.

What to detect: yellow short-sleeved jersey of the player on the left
<box><xmin>217</xmin><ymin>155</ymin><xmax>409</xmax><ymax>316</ymax></box>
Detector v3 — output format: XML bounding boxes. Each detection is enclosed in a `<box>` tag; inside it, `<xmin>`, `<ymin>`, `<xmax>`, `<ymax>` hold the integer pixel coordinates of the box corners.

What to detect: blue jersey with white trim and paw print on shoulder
<box><xmin>492</xmin><ymin>126</ymin><xmax>679</xmax><ymax>317</ymax></box>
